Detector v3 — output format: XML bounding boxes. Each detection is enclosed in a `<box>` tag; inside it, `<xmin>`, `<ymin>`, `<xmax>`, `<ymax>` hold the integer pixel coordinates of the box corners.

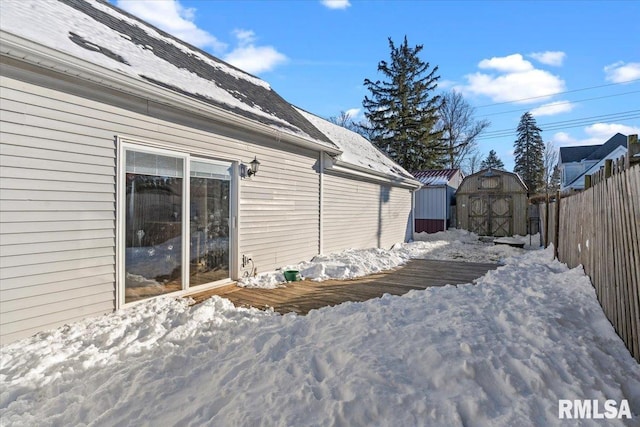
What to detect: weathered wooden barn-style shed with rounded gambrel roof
<box><xmin>456</xmin><ymin>168</ymin><xmax>528</xmax><ymax>237</ymax></box>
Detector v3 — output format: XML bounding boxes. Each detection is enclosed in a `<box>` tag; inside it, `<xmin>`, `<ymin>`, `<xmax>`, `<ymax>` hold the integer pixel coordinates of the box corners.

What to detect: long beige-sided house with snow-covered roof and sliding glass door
<box><xmin>0</xmin><ymin>0</ymin><xmax>420</xmax><ymax>343</ymax></box>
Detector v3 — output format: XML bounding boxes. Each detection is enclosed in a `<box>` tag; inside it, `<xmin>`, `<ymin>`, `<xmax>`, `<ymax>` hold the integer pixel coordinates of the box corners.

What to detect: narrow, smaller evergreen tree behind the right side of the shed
<box><xmin>513</xmin><ymin>112</ymin><xmax>545</xmax><ymax>194</ymax></box>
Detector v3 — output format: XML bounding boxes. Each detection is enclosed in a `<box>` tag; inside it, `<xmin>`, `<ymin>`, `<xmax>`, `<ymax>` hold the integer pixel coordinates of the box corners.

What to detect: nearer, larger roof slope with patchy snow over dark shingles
<box><xmin>0</xmin><ymin>0</ymin><xmax>335</xmax><ymax>148</ymax></box>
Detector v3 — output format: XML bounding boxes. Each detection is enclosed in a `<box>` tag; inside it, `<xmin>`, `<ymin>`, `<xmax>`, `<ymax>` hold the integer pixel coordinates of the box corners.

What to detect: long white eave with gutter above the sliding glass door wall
<box><xmin>0</xmin><ymin>30</ymin><xmax>342</xmax><ymax>155</ymax></box>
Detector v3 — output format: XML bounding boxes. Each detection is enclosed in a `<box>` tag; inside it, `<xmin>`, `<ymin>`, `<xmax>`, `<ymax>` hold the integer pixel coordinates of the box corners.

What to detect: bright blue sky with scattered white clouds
<box><xmin>111</xmin><ymin>0</ymin><xmax>640</xmax><ymax>169</ymax></box>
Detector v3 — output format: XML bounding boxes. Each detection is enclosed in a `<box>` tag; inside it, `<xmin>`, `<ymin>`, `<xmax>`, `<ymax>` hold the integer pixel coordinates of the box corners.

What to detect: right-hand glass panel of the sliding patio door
<box><xmin>189</xmin><ymin>161</ymin><xmax>231</xmax><ymax>286</ymax></box>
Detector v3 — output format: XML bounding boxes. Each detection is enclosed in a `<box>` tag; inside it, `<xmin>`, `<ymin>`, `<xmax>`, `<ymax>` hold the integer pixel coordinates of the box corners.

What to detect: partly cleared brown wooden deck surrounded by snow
<box><xmin>188</xmin><ymin>259</ymin><xmax>499</xmax><ymax>314</ymax></box>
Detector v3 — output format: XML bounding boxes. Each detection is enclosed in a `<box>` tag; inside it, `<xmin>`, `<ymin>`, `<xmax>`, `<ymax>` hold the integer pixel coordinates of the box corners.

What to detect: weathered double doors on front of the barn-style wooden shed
<box><xmin>469</xmin><ymin>195</ymin><xmax>513</xmax><ymax>237</ymax></box>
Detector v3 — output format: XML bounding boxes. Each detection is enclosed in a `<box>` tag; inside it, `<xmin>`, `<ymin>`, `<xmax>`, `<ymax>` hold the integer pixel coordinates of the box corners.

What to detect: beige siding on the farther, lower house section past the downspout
<box><xmin>323</xmin><ymin>173</ymin><xmax>411</xmax><ymax>253</ymax></box>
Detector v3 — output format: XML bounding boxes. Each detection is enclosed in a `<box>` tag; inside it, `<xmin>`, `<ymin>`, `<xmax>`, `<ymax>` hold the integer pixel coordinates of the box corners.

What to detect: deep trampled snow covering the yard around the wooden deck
<box><xmin>0</xmin><ymin>232</ymin><xmax>640</xmax><ymax>426</ymax></box>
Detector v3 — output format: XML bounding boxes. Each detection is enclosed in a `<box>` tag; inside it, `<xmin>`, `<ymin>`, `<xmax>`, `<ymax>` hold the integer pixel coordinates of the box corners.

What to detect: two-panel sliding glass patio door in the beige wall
<box><xmin>120</xmin><ymin>146</ymin><xmax>232</xmax><ymax>303</ymax></box>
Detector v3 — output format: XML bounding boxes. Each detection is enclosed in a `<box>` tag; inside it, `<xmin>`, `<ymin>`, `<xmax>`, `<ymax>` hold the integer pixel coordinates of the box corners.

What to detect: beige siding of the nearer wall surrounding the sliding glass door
<box><xmin>0</xmin><ymin>64</ymin><xmax>319</xmax><ymax>343</ymax></box>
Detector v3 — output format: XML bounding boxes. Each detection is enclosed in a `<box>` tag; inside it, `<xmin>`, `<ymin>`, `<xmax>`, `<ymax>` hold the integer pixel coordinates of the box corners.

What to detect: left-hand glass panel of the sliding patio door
<box><xmin>124</xmin><ymin>150</ymin><xmax>184</xmax><ymax>303</ymax></box>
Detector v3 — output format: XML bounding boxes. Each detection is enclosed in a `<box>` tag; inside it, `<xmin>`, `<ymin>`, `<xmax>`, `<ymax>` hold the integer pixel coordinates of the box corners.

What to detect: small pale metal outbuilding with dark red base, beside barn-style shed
<box><xmin>413</xmin><ymin>169</ymin><xmax>463</xmax><ymax>233</ymax></box>
